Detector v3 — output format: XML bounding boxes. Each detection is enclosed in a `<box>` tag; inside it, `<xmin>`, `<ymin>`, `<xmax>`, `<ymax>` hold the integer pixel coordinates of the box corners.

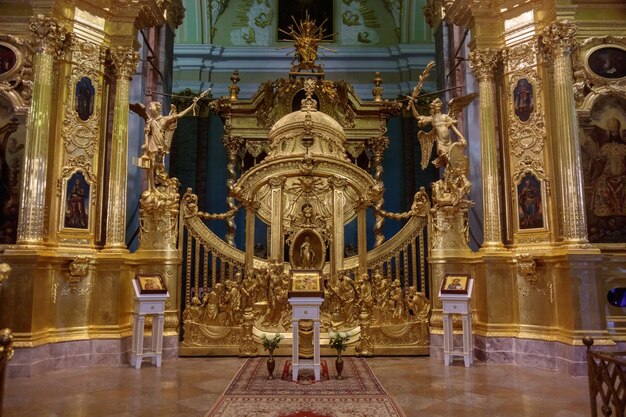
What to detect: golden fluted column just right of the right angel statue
<box><xmin>470</xmin><ymin>48</ymin><xmax>504</xmax><ymax>250</ymax></box>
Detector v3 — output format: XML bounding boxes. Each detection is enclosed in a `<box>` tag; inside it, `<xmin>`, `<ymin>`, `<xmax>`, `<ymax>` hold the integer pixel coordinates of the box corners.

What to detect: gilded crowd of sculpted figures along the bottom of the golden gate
<box><xmin>183</xmin><ymin>262</ymin><xmax>430</xmax><ymax>330</ymax></box>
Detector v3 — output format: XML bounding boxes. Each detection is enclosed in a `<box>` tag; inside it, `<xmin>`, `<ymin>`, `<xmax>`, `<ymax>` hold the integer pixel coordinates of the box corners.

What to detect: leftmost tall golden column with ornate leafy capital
<box><xmin>17</xmin><ymin>15</ymin><xmax>68</xmax><ymax>245</ymax></box>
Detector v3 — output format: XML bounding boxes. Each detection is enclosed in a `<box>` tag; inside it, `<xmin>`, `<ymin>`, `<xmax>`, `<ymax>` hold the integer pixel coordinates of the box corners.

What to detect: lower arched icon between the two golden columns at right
<box><xmin>517</xmin><ymin>172</ymin><xmax>545</xmax><ymax>230</ymax></box>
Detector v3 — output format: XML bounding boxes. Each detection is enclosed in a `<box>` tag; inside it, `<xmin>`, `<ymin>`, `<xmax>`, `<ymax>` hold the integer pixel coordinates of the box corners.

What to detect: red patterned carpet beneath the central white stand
<box><xmin>206</xmin><ymin>357</ymin><xmax>405</xmax><ymax>417</ymax></box>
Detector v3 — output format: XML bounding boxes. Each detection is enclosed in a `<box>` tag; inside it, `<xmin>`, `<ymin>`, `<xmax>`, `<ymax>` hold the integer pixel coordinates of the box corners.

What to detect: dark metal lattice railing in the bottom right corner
<box><xmin>583</xmin><ymin>337</ymin><xmax>626</xmax><ymax>417</ymax></box>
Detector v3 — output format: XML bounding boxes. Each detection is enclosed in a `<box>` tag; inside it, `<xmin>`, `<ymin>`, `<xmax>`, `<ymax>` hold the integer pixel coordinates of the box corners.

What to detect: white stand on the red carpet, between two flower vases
<box><xmin>289</xmin><ymin>297</ymin><xmax>324</xmax><ymax>381</ymax></box>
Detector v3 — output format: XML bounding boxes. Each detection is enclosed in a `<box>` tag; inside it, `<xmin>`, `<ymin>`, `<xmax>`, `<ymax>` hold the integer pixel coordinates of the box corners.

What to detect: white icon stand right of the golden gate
<box><xmin>439</xmin><ymin>280</ymin><xmax>474</xmax><ymax>368</ymax></box>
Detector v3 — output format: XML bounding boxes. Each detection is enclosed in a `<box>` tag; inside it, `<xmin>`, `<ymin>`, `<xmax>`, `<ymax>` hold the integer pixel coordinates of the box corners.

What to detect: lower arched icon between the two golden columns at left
<box><xmin>63</xmin><ymin>171</ymin><xmax>91</xmax><ymax>229</ymax></box>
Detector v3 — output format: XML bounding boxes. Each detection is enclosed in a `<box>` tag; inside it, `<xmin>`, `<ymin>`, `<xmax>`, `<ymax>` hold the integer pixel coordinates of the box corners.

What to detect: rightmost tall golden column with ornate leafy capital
<box><xmin>541</xmin><ymin>20</ymin><xmax>588</xmax><ymax>245</ymax></box>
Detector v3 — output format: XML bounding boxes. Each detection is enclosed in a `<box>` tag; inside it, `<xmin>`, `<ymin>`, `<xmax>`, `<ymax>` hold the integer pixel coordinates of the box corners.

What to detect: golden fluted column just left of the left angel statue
<box><xmin>104</xmin><ymin>46</ymin><xmax>139</xmax><ymax>251</ymax></box>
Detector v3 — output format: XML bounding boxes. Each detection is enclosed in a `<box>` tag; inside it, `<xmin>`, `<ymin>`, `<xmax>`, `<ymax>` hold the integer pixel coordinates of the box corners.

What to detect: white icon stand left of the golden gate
<box><xmin>130</xmin><ymin>280</ymin><xmax>170</xmax><ymax>369</ymax></box>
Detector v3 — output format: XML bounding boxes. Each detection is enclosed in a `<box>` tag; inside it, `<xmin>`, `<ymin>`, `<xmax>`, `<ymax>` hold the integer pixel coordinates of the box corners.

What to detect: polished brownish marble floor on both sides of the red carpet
<box><xmin>2</xmin><ymin>357</ymin><xmax>590</xmax><ymax>417</ymax></box>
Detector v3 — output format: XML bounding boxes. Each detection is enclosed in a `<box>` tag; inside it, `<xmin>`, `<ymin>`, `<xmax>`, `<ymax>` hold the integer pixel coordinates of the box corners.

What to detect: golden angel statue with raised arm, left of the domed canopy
<box><xmin>130</xmin><ymin>88</ymin><xmax>211</xmax><ymax>192</ymax></box>
